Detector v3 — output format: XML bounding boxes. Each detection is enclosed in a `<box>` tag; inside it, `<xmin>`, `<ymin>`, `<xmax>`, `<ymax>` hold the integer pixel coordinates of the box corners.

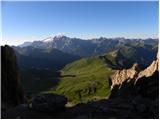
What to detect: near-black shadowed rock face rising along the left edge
<box><xmin>1</xmin><ymin>45</ymin><xmax>24</xmax><ymax>111</ymax></box>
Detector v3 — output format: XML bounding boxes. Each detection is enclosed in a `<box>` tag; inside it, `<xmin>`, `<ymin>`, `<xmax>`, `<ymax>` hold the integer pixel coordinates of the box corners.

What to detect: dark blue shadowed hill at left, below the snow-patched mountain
<box><xmin>14</xmin><ymin>46</ymin><xmax>80</xmax><ymax>71</ymax></box>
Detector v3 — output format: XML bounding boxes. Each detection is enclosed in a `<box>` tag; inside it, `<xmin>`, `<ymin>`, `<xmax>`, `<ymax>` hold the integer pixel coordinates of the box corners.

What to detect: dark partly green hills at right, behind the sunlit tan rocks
<box><xmin>101</xmin><ymin>43</ymin><xmax>158</xmax><ymax>68</ymax></box>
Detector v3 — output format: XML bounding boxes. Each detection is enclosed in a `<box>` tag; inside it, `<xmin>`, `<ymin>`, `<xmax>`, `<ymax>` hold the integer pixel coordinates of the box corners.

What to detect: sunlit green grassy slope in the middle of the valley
<box><xmin>50</xmin><ymin>57</ymin><xmax>113</xmax><ymax>103</ymax></box>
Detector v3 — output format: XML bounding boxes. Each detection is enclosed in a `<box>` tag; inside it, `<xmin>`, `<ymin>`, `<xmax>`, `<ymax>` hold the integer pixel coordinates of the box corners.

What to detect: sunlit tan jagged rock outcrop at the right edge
<box><xmin>111</xmin><ymin>51</ymin><xmax>159</xmax><ymax>89</ymax></box>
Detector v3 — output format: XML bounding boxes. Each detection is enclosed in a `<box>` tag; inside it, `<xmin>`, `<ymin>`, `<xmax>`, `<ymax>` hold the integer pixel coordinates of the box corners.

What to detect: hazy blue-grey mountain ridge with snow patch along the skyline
<box><xmin>17</xmin><ymin>36</ymin><xmax>158</xmax><ymax>61</ymax></box>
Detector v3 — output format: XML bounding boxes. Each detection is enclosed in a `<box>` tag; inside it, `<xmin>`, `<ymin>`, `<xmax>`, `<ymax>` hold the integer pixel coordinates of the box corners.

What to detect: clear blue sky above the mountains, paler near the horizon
<box><xmin>1</xmin><ymin>1</ymin><xmax>158</xmax><ymax>45</ymax></box>
